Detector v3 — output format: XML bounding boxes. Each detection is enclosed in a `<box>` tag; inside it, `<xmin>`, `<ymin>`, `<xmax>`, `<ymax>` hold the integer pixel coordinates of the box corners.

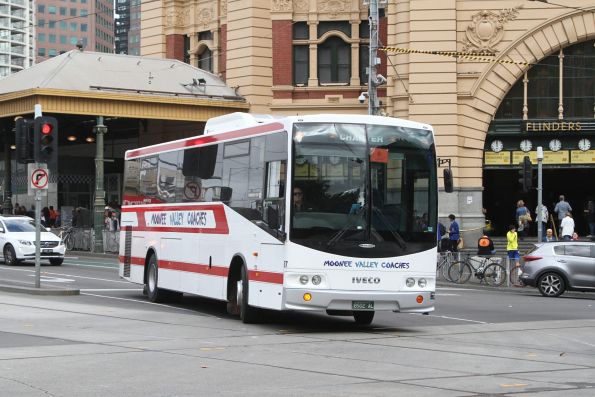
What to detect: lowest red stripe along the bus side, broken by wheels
<box><xmin>120</xmin><ymin>256</ymin><xmax>283</xmax><ymax>284</ymax></box>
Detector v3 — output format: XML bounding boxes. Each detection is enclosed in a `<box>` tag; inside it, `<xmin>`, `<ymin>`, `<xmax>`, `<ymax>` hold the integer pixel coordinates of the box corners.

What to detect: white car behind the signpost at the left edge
<box><xmin>0</xmin><ymin>215</ymin><xmax>66</xmax><ymax>266</ymax></box>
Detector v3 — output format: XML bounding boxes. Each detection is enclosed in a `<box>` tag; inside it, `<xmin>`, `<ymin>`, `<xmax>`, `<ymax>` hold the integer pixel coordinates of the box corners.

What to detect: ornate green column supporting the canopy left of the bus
<box><xmin>93</xmin><ymin>116</ymin><xmax>107</xmax><ymax>252</ymax></box>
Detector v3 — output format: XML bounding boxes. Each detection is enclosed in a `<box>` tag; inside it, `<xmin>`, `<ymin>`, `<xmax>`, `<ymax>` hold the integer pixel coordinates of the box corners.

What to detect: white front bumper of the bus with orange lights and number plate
<box><xmin>285</xmin><ymin>289</ymin><xmax>435</xmax><ymax>313</ymax></box>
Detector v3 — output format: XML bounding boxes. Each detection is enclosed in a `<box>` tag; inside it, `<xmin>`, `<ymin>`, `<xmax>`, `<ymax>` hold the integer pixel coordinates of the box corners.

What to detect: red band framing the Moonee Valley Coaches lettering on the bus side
<box><xmin>122</xmin><ymin>204</ymin><xmax>229</xmax><ymax>234</ymax></box>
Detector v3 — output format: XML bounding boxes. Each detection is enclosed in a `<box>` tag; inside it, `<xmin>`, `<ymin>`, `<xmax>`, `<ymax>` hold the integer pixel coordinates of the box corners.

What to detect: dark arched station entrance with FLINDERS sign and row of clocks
<box><xmin>483</xmin><ymin>39</ymin><xmax>595</xmax><ymax>236</ymax></box>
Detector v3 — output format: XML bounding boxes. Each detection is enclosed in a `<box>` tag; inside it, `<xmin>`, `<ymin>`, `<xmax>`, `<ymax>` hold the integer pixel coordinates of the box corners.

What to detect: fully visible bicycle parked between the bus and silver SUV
<box><xmin>448</xmin><ymin>255</ymin><xmax>506</xmax><ymax>287</ymax></box>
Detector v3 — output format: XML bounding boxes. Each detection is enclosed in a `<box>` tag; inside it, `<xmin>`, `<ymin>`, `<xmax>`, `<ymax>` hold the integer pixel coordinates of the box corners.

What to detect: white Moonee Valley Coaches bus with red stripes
<box><xmin>119</xmin><ymin>113</ymin><xmax>448</xmax><ymax>324</ymax></box>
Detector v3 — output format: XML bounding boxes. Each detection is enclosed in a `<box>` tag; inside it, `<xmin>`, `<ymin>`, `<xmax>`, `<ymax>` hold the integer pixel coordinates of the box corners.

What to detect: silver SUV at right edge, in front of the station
<box><xmin>521</xmin><ymin>241</ymin><xmax>595</xmax><ymax>297</ymax></box>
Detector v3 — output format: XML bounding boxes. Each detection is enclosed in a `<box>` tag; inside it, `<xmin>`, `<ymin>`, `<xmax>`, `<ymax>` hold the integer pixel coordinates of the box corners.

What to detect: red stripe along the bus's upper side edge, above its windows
<box><xmin>126</xmin><ymin>123</ymin><xmax>283</xmax><ymax>160</ymax></box>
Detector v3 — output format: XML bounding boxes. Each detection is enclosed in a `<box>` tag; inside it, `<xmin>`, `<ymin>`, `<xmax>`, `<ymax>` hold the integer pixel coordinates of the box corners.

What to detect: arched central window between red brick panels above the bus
<box><xmin>318</xmin><ymin>36</ymin><xmax>351</xmax><ymax>84</ymax></box>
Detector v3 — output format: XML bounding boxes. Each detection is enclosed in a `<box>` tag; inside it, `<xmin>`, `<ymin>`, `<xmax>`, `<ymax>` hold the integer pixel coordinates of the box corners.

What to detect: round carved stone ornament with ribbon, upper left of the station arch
<box><xmin>463</xmin><ymin>5</ymin><xmax>523</xmax><ymax>54</ymax></box>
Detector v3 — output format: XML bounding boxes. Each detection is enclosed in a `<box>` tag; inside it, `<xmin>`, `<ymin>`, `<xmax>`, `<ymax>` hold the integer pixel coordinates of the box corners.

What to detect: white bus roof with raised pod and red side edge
<box><xmin>124</xmin><ymin>112</ymin><xmax>432</xmax><ymax>160</ymax></box>
